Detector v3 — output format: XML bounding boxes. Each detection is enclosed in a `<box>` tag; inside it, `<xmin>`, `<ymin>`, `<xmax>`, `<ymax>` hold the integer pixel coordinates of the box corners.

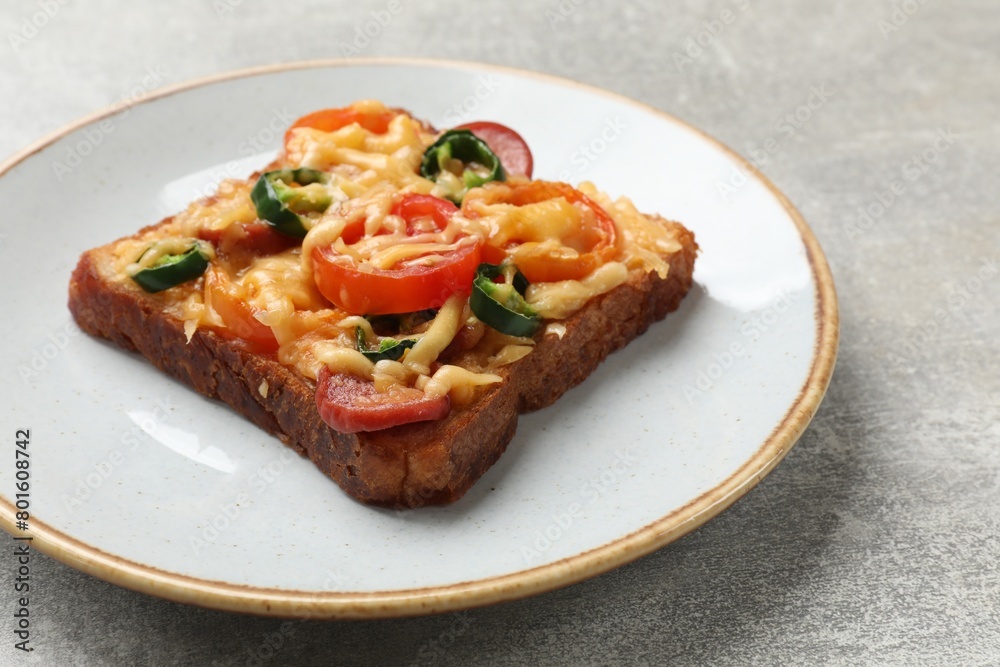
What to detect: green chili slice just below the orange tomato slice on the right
<box><xmin>469</xmin><ymin>264</ymin><xmax>542</xmax><ymax>338</ymax></box>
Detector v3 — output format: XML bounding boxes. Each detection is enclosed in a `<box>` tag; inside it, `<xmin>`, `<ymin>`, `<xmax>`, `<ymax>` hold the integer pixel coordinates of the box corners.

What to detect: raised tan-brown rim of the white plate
<box><xmin>0</xmin><ymin>57</ymin><xmax>840</xmax><ymax>619</ymax></box>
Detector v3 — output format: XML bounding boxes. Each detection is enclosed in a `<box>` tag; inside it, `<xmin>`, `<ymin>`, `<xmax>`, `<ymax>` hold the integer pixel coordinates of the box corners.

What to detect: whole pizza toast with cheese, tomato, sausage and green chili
<box><xmin>69</xmin><ymin>101</ymin><xmax>697</xmax><ymax>507</ymax></box>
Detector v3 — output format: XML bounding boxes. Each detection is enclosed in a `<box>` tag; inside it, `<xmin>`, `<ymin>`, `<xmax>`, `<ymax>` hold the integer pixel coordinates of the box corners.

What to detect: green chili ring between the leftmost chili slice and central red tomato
<box><xmin>250</xmin><ymin>167</ymin><xmax>333</xmax><ymax>239</ymax></box>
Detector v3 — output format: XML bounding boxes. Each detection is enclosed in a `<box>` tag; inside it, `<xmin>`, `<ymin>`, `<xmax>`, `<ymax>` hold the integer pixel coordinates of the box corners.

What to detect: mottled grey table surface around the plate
<box><xmin>0</xmin><ymin>0</ymin><xmax>1000</xmax><ymax>665</ymax></box>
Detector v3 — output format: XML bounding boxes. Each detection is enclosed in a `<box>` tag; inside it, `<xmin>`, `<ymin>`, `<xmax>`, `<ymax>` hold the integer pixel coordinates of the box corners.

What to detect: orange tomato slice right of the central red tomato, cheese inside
<box><xmin>462</xmin><ymin>181</ymin><xmax>618</xmax><ymax>283</ymax></box>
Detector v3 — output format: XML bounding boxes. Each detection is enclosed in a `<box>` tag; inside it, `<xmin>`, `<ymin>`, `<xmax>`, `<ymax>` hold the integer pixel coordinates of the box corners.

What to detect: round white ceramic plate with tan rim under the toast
<box><xmin>0</xmin><ymin>60</ymin><xmax>837</xmax><ymax>617</ymax></box>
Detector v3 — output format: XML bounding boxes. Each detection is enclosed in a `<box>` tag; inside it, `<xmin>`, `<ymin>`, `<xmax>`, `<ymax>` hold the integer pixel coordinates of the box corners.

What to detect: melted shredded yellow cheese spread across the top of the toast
<box><xmin>109</xmin><ymin>100</ymin><xmax>680</xmax><ymax>404</ymax></box>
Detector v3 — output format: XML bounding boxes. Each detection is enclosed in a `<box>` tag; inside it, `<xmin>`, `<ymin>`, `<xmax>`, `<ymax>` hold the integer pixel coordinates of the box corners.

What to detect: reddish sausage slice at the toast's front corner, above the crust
<box><xmin>316</xmin><ymin>366</ymin><xmax>451</xmax><ymax>433</ymax></box>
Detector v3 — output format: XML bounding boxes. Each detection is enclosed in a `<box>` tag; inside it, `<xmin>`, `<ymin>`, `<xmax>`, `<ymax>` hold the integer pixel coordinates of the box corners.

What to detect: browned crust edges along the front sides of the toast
<box><xmin>69</xmin><ymin>223</ymin><xmax>697</xmax><ymax>507</ymax></box>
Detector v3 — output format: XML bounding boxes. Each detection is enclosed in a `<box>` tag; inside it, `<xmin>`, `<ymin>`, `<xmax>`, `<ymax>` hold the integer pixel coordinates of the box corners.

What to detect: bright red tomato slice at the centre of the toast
<box><xmin>312</xmin><ymin>194</ymin><xmax>482</xmax><ymax>315</ymax></box>
